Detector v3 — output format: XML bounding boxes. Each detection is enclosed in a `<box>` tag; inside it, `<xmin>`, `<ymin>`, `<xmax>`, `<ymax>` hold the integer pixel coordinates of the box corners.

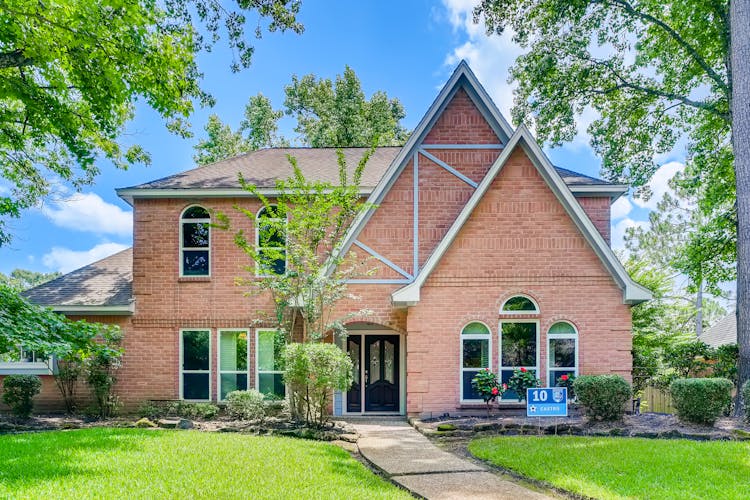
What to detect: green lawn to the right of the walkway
<box><xmin>469</xmin><ymin>436</ymin><xmax>750</xmax><ymax>499</ymax></box>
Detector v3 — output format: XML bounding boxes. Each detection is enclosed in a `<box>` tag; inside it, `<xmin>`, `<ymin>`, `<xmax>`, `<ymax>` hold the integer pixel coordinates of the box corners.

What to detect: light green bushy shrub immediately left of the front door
<box><xmin>284</xmin><ymin>343</ymin><xmax>352</xmax><ymax>425</ymax></box>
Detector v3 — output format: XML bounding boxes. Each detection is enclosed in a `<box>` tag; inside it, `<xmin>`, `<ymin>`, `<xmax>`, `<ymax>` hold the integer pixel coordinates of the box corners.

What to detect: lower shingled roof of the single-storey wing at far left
<box><xmin>23</xmin><ymin>248</ymin><xmax>133</xmax><ymax>314</ymax></box>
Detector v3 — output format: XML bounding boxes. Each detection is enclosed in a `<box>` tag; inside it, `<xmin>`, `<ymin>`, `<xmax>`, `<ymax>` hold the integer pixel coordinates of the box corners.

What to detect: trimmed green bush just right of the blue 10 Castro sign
<box><xmin>573</xmin><ymin>375</ymin><xmax>633</xmax><ymax>420</ymax></box>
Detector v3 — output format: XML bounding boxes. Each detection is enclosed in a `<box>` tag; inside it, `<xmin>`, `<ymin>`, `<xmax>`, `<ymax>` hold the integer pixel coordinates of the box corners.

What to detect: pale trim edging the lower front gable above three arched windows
<box><xmin>391</xmin><ymin>125</ymin><xmax>651</xmax><ymax>306</ymax></box>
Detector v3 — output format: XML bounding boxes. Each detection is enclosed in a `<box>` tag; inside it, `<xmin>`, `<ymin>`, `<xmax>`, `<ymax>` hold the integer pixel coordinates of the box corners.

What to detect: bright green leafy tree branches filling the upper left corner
<box><xmin>0</xmin><ymin>0</ymin><xmax>303</xmax><ymax>245</ymax></box>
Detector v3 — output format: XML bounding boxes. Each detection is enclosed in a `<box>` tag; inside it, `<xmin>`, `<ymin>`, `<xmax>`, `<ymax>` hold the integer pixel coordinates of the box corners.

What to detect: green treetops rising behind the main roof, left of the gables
<box><xmin>193</xmin><ymin>66</ymin><xmax>409</xmax><ymax>165</ymax></box>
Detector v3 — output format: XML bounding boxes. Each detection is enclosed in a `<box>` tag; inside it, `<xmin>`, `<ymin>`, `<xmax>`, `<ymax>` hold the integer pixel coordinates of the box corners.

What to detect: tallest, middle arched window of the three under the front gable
<box><xmin>499</xmin><ymin>295</ymin><xmax>539</xmax><ymax>401</ymax></box>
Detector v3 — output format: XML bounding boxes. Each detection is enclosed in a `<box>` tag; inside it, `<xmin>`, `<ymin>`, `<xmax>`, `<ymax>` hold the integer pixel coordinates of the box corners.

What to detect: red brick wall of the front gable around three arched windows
<box><xmin>407</xmin><ymin>148</ymin><xmax>631</xmax><ymax>413</ymax></box>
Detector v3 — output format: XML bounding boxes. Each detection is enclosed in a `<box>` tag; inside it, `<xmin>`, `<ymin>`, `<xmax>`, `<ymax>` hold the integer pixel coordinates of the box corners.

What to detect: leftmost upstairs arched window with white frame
<box><xmin>180</xmin><ymin>205</ymin><xmax>211</xmax><ymax>276</ymax></box>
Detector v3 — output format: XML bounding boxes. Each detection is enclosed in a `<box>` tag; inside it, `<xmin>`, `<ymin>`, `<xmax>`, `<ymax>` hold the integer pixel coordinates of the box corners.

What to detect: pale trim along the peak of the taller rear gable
<box><xmin>326</xmin><ymin>60</ymin><xmax>513</xmax><ymax>274</ymax></box>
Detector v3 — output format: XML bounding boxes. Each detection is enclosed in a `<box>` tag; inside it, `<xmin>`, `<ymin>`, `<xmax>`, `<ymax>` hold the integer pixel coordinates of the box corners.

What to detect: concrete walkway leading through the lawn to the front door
<box><xmin>350</xmin><ymin>419</ymin><xmax>549</xmax><ymax>500</ymax></box>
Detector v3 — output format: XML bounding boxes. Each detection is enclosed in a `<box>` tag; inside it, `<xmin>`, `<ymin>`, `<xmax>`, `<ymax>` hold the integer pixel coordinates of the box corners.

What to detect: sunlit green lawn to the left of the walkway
<box><xmin>0</xmin><ymin>429</ymin><xmax>410</xmax><ymax>500</ymax></box>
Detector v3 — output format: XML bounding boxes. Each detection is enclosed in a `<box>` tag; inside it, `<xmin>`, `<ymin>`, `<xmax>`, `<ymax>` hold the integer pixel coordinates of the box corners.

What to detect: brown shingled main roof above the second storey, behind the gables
<box><xmin>118</xmin><ymin>147</ymin><xmax>620</xmax><ymax>193</ymax></box>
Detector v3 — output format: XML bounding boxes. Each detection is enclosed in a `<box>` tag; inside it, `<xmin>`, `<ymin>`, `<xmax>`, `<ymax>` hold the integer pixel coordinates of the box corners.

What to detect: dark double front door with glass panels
<box><xmin>346</xmin><ymin>335</ymin><xmax>400</xmax><ymax>413</ymax></box>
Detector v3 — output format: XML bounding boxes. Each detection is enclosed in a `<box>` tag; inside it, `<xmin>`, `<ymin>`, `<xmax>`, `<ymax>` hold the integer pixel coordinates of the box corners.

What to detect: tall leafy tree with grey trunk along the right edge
<box><xmin>474</xmin><ymin>0</ymin><xmax>750</xmax><ymax>411</ymax></box>
